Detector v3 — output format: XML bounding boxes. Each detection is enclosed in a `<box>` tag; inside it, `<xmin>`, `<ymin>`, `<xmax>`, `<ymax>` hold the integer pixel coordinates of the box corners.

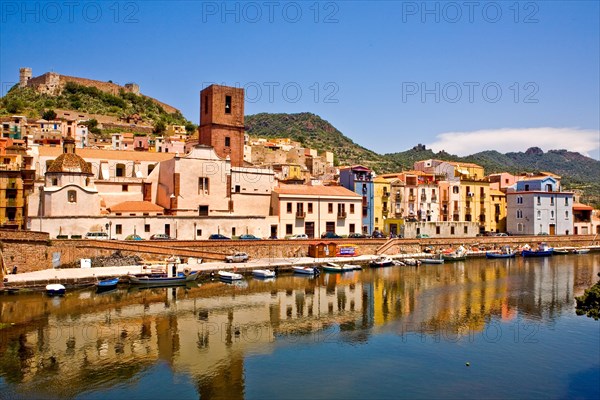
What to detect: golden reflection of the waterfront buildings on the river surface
<box><xmin>0</xmin><ymin>255</ymin><xmax>600</xmax><ymax>399</ymax></box>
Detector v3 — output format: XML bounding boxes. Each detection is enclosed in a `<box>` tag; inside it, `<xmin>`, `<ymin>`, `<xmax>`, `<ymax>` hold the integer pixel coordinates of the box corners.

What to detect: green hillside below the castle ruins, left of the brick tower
<box><xmin>0</xmin><ymin>82</ymin><xmax>195</xmax><ymax>132</ymax></box>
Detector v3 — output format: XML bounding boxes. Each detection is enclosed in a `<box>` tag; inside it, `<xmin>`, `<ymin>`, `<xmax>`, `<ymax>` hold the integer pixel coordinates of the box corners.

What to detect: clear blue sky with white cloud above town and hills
<box><xmin>0</xmin><ymin>1</ymin><xmax>600</xmax><ymax>159</ymax></box>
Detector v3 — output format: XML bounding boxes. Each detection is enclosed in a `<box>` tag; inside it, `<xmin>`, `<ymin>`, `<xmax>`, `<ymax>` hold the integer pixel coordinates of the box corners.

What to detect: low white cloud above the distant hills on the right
<box><xmin>427</xmin><ymin>128</ymin><xmax>600</xmax><ymax>159</ymax></box>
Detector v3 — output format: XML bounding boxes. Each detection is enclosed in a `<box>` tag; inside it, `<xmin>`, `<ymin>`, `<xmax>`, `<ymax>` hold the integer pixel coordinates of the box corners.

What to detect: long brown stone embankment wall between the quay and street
<box><xmin>0</xmin><ymin>230</ymin><xmax>600</xmax><ymax>275</ymax></box>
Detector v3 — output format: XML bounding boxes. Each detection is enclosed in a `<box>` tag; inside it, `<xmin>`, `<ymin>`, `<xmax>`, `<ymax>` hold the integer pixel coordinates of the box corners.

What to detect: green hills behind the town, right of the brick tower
<box><xmin>246</xmin><ymin>113</ymin><xmax>600</xmax><ymax>207</ymax></box>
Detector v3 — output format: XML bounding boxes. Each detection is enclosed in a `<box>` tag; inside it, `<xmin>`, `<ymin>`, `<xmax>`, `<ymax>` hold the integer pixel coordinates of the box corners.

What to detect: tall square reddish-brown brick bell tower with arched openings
<box><xmin>198</xmin><ymin>85</ymin><xmax>244</xmax><ymax>167</ymax></box>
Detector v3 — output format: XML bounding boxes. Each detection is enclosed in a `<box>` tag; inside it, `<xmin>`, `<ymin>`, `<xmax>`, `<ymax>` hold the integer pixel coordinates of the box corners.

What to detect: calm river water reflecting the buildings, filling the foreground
<box><xmin>0</xmin><ymin>254</ymin><xmax>600</xmax><ymax>399</ymax></box>
